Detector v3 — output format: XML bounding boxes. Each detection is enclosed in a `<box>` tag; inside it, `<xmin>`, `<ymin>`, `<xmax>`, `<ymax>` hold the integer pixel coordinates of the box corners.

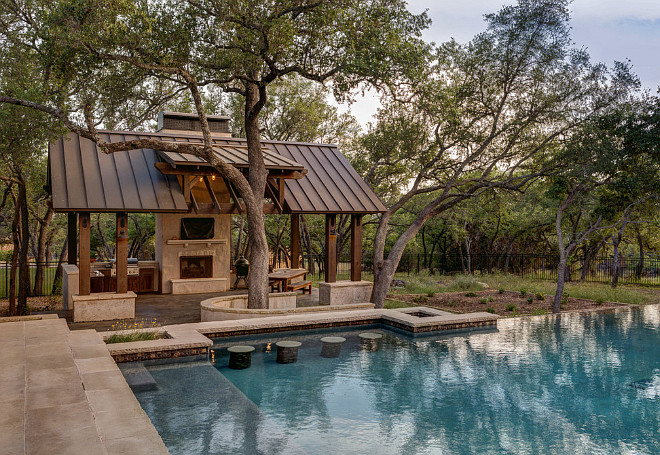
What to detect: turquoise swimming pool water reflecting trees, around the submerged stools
<box><xmin>136</xmin><ymin>305</ymin><xmax>660</xmax><ymax>455</ymax></box>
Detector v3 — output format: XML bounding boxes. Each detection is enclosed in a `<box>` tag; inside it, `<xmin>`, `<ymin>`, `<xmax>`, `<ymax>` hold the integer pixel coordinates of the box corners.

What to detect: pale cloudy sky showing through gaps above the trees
<box><xmin>340</xmin><ymin>0</ymin><xmax>660</xmax><ymax>125</ymax></box>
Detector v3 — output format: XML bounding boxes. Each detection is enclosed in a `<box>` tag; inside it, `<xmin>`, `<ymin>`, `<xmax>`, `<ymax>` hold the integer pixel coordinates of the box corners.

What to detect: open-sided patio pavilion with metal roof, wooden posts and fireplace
<box><xmin>46</xmin><ymin>112</ymin><xmax>385</xmax><ymax>328</ymax></box>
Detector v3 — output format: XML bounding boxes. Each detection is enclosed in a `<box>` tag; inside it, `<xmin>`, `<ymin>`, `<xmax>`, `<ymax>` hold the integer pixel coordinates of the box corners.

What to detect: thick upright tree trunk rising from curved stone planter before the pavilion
<box><xmin>245</xmin><ymin>82</ymin><xmax>268</xmax><ymax>309</ymax></box>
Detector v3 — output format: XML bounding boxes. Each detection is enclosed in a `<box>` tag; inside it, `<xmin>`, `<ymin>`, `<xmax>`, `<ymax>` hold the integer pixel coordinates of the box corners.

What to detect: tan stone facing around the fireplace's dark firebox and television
<box><xmin>155</xmin><ymin>213</ymin><xmax>231</xmax><ymax>294</ymax></box>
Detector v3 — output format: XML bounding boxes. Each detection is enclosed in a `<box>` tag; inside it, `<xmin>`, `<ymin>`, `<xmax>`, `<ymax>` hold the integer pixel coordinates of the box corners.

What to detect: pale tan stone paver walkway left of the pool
<box><xmin>0</xmin><ymin>315</ymin><xmax>168</xmax><ymax>455</ymax></box>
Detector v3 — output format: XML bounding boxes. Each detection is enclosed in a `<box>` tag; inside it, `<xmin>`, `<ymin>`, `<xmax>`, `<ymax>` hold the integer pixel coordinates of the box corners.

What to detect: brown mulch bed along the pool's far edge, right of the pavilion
<box><xmin>388</xmin><ymin>290</ymin><xmax>626</xmax><ymax>316</ymax></box>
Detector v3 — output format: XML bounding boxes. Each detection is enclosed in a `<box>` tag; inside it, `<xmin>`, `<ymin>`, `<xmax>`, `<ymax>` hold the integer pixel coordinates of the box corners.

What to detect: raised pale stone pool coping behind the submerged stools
<box><xmin>106</xmin><ymin>307</ymin><xmax>499</xmax><ymax>363</ymax></box>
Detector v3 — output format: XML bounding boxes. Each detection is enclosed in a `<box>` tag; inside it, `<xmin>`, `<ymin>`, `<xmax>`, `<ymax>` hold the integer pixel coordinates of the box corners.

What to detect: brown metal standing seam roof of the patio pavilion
<box><xmin>48</xmin><ymin>131</ymin><xmax>386</xmax><ymax>213</ymax></box>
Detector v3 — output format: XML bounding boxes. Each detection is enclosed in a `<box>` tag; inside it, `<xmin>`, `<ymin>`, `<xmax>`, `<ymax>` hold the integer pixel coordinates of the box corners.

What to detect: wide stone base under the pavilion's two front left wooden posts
<box><xmin>71</xmin><ymin>291</ymin><xmax>137</xmax><ymax>322</ymax></box>
